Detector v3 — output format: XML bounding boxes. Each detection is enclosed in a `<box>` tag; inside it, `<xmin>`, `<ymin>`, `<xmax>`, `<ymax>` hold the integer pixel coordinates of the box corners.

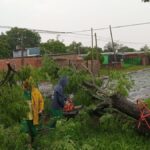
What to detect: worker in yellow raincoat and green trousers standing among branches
<box><xmin>23</xmin><ymin>77</ymin><xmax>44</xmax><ymax>141</ymax></box>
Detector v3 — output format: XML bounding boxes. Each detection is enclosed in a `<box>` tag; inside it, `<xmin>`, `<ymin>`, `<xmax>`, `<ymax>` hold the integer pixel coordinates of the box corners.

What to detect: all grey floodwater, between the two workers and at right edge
<box><xmin>39</xmin><ymin>68</ymin><xmax>150</xmax><ymax>101</ymax></box>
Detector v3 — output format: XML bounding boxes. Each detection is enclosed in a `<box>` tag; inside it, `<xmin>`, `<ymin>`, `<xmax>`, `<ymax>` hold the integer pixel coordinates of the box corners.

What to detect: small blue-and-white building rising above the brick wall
<box><xmin>13</xmin><ymin>47</ymin><xmax>40</xmax><ymax>58</ymax></box>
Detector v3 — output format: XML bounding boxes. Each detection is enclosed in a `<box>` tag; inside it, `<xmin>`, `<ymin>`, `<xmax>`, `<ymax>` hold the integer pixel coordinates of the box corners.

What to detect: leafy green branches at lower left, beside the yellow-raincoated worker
<box><xmin>0</xmin><ymin>78</ymin><xmax>29</xmax><ymax>150</ymax></box>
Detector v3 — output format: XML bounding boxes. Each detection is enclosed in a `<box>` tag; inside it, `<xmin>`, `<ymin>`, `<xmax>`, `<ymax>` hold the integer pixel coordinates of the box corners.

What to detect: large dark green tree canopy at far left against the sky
<box><xmin>0</xmin><ymin>27</ymin><xmax>41</xmax><ymax>58</ymax></box>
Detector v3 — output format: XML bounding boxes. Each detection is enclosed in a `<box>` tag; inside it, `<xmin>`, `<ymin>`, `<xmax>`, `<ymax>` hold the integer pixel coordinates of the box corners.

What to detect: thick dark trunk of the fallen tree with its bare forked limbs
<box><xmin>84</xmin><ymin>79</ymin><xmax>150</xmax><ymax>133</ymax></box>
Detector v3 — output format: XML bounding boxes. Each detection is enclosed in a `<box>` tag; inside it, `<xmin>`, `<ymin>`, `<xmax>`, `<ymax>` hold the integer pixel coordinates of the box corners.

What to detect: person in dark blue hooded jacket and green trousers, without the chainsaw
<box><xmin>51</xmin><ymin>77</ymin><xmax>68</xmax><ymax>128</ymax></box>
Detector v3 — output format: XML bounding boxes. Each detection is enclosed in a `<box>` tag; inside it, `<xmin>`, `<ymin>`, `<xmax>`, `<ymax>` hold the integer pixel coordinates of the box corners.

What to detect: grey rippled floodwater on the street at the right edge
<box><xmin>128</xmin><ymin>69</ymin><xmax>150</xmax><ymax>101</ymax></box>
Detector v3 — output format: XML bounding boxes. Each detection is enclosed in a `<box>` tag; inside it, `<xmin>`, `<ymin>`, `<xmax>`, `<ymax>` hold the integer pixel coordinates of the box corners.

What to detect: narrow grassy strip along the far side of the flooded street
<box><xmin>100</xmin><ymin>65</ymin><xmax>150</xmax><ymax>75</ymax></box>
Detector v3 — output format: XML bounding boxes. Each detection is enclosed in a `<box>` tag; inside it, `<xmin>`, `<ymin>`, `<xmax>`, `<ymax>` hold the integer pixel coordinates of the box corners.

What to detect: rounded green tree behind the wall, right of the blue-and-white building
<box><xmin>41</xmin><ymin>40</ymin><xmax>66</xmax><ymax>54</ymax></box>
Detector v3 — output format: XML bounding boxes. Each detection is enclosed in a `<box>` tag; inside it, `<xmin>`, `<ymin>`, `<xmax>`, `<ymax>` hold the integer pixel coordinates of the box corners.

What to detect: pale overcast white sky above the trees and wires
<box><xmin>0</xmin><ymin>0</ymin><xmax>150</xmax><ymax>48</ymax></box>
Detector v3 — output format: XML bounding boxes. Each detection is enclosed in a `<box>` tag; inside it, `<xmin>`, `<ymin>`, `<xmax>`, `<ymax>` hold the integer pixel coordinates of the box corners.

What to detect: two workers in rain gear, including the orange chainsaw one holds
<box><xmin>23</xmin><ymin>77</ymin><xmax>80</xmax><ymax>142</ymax></box>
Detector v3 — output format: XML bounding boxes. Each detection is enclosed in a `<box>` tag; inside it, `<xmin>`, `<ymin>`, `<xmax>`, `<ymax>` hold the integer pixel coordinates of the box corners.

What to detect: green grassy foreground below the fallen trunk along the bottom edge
<box><xmin>34</xmin><ymin>114</ymin><xmax>150</xmax><ymax>150</ymax></box>
